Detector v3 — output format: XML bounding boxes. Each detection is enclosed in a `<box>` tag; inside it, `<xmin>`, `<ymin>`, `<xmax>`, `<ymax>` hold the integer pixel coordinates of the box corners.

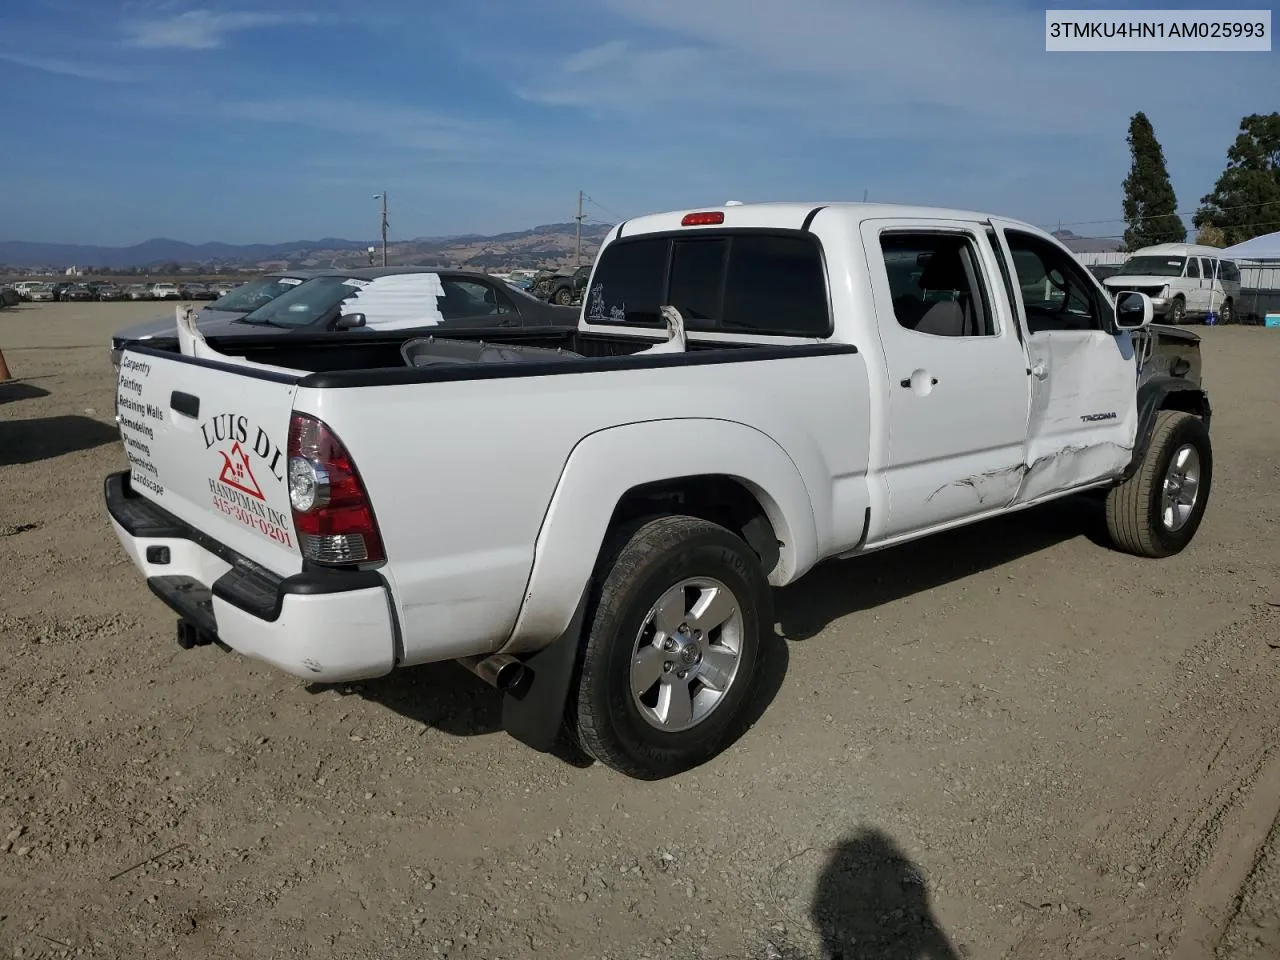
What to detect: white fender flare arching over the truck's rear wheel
<box><xmin>502</xmin><ymin>419</ymin><xmax>818</xmax><ymax>654</ymax></box>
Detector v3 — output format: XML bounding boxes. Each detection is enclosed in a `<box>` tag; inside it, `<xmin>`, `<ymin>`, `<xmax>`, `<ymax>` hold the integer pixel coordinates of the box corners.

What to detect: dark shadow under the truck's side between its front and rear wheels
<box><xmin>774</xmin><ymin>494</ymin><xmax>1106</xmax><ymax>640</ymax></box>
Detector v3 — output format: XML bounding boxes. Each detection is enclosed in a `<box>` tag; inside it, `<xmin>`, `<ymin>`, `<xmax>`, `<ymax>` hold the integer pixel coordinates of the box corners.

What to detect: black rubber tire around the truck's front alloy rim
<box><xmin>1106</xmin><ymin>410</ymin><xmax>1213</xmax><ymax>558</ymax></box>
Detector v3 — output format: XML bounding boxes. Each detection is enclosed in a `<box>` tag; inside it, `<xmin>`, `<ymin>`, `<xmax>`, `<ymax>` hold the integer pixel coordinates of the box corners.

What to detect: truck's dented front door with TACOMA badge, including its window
<box><xmin>992</xmin><ymin>220</ymin><xmax>1138</xmax><ymax>503</ymax></box>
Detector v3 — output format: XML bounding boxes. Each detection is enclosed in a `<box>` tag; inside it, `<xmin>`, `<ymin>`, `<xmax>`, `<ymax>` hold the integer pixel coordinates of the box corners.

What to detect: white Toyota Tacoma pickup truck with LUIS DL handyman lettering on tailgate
<box><xmin>105</xmin><ymin>204</ymin><xmax>1212</xmax><ymax>778</ymax></box>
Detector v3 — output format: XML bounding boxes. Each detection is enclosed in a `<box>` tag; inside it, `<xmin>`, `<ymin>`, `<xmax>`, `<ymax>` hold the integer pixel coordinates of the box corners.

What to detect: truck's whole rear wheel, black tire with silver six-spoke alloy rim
<box><xmin>570</xmin><ymin>516</ymin><xmax>772</xmax><ymax>780</ymax></box>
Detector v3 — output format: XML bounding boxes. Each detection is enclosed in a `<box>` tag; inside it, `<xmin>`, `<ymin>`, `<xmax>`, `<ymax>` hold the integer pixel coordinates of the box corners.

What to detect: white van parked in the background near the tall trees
<box><xmin>1103</xmin><ymin>243</ymin><xmax>1240</xmax><ymax>324</ymax></box>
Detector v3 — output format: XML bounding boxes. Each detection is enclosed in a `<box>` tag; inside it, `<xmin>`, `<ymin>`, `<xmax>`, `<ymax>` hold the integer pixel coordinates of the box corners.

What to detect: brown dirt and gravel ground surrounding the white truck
<box><xmin>0</xmin><ymin>303</ymin><xmax>1280</xmax><ymax>960</ymax></box>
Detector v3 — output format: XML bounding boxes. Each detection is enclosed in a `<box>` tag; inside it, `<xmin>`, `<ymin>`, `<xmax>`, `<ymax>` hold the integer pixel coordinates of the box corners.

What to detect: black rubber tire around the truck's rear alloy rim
<box><xmin>568</xmin><ymin>516</ymin><xmax>773</xmax><ymax>780</ymax></box>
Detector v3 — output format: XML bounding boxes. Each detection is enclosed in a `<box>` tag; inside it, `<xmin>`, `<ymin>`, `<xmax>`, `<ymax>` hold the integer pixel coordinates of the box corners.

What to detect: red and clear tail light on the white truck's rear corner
<box><xmin>288</xmin><ymin>413</ymin><xmax>387</xmax><ymax>564</ymax></box>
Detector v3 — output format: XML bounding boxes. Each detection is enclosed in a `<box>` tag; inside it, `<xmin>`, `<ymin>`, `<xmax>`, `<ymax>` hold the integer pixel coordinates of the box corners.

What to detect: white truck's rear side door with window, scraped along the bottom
<box><xmin>861</xmin><ymin>220</ymin><xmax>1029</xmax><ymax>541</ymax></box>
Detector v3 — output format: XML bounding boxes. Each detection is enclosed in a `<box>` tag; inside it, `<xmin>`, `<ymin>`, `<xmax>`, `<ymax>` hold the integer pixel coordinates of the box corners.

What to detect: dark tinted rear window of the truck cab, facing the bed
<box><xmin>585</xmin><ymin>229</ymin><xmax>832</xmax><ymax>338</ymax></box>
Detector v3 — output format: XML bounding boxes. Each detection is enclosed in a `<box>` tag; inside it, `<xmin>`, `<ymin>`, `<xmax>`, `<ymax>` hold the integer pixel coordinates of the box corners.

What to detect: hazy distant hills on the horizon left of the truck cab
<box><xmin>0</xmin><ymin>223</ymin><xmax>609</xmax><ymax>270</ymax></box>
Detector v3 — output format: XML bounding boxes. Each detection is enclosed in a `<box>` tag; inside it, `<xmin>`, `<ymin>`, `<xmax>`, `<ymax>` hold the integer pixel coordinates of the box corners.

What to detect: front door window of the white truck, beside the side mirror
<box><xmin>1005</xmin><ymin>230</ymin><xmax>1106</xmax><ymax>334</ymax></box>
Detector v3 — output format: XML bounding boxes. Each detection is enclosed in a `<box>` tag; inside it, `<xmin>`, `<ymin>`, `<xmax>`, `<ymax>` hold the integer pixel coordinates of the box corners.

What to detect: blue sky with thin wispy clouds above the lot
<box><xmin>0</xmin><ymin>0</ymin><xmax>1280</xmax><ymax>246</ymax></box>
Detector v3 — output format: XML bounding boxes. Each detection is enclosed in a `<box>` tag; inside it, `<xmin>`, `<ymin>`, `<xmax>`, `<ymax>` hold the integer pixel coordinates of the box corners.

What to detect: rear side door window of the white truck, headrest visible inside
<box><xmin>881</xmin><ymin>233</ymin><xmax>996</xmax><ymax>337</ymax></box>
